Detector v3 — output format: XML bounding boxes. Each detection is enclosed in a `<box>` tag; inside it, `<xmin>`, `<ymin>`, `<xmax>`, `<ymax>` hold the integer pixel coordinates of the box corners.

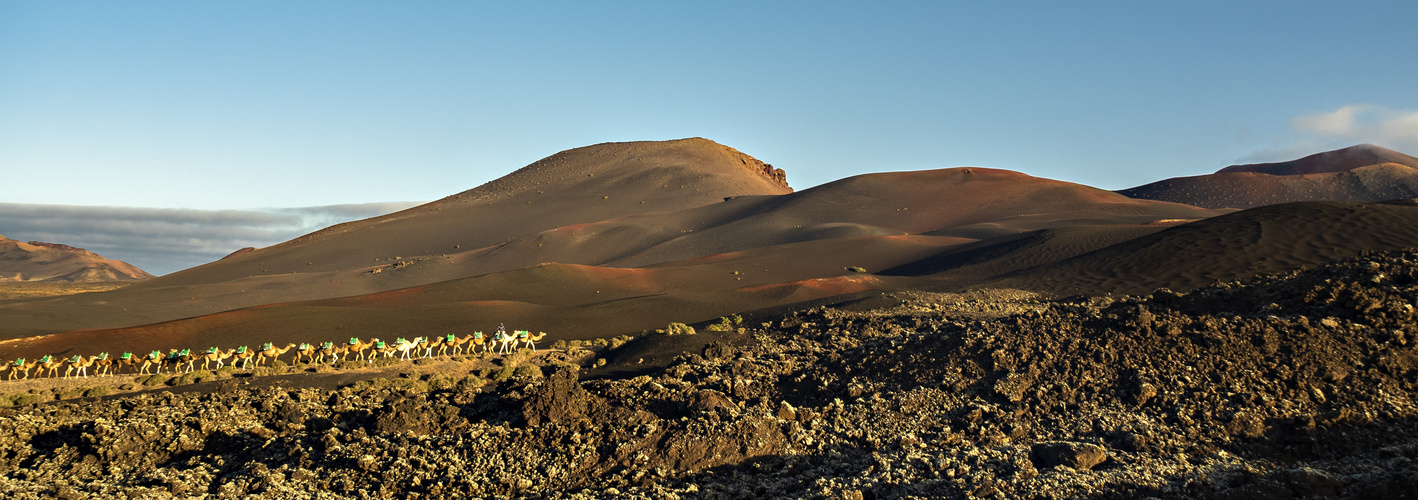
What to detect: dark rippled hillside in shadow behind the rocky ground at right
<box><xmin>974</xmin><ymin>201</ymin><xmax>1418</xmax><ymax>296</ymax></box>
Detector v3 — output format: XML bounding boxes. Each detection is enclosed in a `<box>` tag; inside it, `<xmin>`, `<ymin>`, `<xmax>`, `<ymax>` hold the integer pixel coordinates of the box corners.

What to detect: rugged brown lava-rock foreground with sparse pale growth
<box><xmin>0</xmin><ymin>252</ymin><xmax>1418</xmax><ymax>499</ymax></box>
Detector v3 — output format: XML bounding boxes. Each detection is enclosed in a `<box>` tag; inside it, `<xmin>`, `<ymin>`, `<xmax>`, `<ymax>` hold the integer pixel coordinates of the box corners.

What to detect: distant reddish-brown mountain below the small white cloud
<box><xmin>1117</xmin><ymin>144</ymin><xmax>1418</xmax><ymax>208</ymax></box>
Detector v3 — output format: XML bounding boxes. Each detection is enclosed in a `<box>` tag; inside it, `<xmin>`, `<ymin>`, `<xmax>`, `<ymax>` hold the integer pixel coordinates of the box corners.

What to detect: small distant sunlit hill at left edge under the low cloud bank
<box><xmin>0</xmin><ymin>237</ymin><xmax>153</xmax><ymax>282</ymax></box>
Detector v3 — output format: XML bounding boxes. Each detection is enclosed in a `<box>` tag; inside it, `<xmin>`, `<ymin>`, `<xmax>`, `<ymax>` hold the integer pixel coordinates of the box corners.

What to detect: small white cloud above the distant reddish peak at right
<box><xmin>1236</xmin><ymin>105</ymin><xmax>1418</xmax><ymax>163</ymax></box>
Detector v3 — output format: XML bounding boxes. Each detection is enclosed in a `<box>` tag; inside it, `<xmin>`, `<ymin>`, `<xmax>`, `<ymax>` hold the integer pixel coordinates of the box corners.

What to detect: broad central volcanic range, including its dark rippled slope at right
<box><xmin>8</xmin><ymin>139</ymin><xmax>1418</xmax><ymax>358</ymax></box>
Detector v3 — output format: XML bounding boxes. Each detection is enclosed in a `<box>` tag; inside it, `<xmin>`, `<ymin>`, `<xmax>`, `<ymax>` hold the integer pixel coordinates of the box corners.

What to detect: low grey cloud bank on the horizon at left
<box><xmin>0</xmin><ymin>201</ymin><xmax>423</xmax><ymax>275</ymax></box>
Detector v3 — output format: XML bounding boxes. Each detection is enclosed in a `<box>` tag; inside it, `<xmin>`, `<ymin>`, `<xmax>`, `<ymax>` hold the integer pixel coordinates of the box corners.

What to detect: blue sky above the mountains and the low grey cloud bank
<box><xmin>0</xmin><ymin>0</ymin><xmax>1418</xmax><ymax>271</ymax></box>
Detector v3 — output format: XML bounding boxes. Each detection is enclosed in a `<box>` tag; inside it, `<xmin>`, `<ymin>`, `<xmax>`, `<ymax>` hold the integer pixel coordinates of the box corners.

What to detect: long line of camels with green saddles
<box><xmin>0</xmin><ymin>326</ymin><xmax>546</xmax><ymax>380</ymax></box>
